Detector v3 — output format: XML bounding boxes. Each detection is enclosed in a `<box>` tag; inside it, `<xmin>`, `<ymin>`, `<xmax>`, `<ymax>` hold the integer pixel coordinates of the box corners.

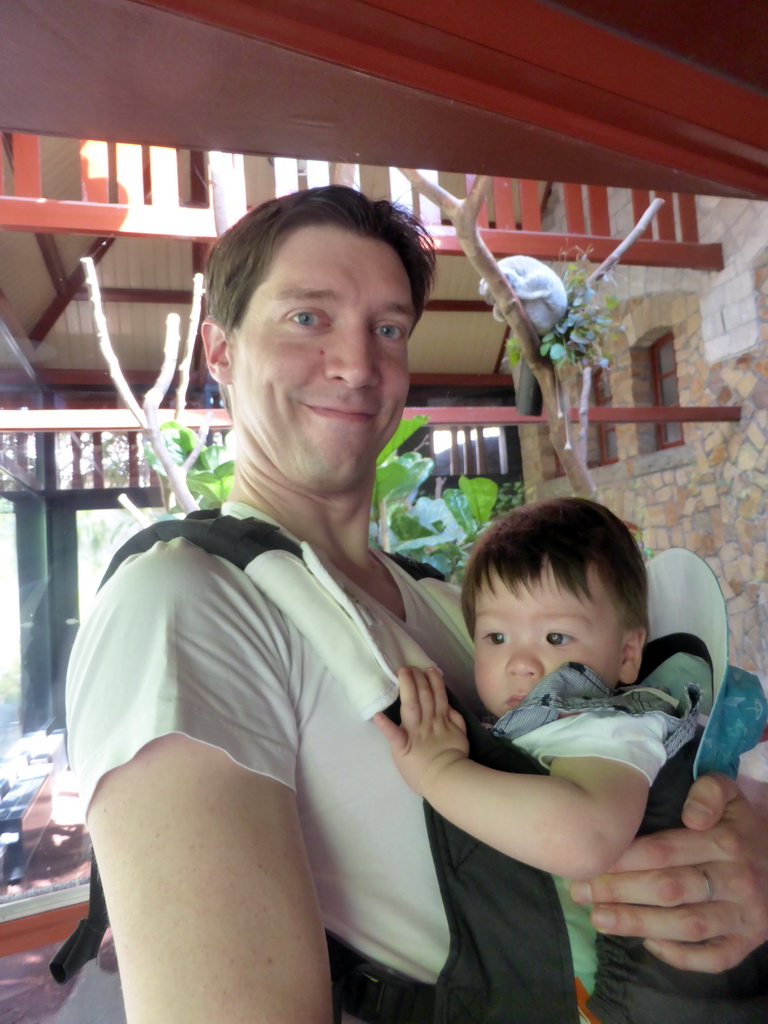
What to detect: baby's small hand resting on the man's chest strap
<box><xmin>374</xmin><ymin>667</ymin><xmax>469</xmax><ymax>799</ymax></box>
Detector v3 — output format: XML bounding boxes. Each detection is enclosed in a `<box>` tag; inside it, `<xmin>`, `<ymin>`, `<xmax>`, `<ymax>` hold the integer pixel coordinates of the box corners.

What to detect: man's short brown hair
<box><xmin>206</xmin><ymin>185</ymin><xmax>435</xmax><ymax>334</ymax></box>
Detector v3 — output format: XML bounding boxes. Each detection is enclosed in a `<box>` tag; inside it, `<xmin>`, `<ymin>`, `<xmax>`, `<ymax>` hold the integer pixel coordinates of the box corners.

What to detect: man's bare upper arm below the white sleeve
<box><xmin>88</xmin><ymin>735</ymin><xmax>332</xmax><ymax>1024</ymax></box>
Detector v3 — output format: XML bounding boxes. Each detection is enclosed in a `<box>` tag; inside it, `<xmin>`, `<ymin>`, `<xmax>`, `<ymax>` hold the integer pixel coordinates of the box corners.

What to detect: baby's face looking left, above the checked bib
<box><xmin>474</xmin><ymin>569</ymin><xmax>645</xmax><ymax>718</ymax></box>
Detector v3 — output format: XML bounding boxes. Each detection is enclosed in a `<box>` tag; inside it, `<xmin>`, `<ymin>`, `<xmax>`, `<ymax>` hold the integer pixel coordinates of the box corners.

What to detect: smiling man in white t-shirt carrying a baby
<box><xmin>69</xmin><ymin>186</ymin><xmax>768</xmax><ymax>1024</ymax></box>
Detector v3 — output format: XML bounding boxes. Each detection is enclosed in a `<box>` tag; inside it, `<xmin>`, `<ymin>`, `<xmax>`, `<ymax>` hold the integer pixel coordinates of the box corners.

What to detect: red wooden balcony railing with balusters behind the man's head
<box><xmin>0</xmin><ymin>134</ymin><xmax>723</xmax><ymax>270</ymax></box>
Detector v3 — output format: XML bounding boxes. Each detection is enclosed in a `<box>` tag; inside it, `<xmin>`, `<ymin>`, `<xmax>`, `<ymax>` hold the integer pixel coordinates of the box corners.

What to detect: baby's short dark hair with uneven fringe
<box><xmin>462</xmin><ymin>498</ymin><xmax>648</xmax><ymax>636</ymax></box>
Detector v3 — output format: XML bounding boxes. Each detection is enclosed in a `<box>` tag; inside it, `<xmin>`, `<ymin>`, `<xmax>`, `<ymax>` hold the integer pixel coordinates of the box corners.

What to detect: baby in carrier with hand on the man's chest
<box><xmin>375</xmin><ymin>498</ymin><xmax>697</xmax><ymax>1015</ymax></box>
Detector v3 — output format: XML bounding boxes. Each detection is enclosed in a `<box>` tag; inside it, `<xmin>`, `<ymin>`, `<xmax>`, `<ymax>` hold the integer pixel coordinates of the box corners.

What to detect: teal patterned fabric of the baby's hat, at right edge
<box><xmin>693</xmin><ymin>665</ymin><xmax>768</xmax><ymax>778</ymax></box>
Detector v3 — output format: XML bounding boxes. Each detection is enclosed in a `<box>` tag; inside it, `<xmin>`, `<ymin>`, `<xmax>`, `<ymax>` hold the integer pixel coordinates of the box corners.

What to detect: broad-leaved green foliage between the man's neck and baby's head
<box><xmin>371</xmin><ymin>417</ymin><xmax>522</xmax><ymax>581</ymax></box>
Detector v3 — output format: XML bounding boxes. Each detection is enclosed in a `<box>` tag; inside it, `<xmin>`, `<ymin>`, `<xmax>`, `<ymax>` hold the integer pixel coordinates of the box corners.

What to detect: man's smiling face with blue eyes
<box><xmin>207</xmin><ymin>225</ymin><xmax>415</xmax><ymax>495</ymax></box>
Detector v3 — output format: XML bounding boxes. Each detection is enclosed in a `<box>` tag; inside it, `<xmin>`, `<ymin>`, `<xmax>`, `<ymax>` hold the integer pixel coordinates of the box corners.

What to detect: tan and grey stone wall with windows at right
<box><xmin>520</xmin><ymin>191</ymin><xmax>768</xmax><ymax>682</ymax></box>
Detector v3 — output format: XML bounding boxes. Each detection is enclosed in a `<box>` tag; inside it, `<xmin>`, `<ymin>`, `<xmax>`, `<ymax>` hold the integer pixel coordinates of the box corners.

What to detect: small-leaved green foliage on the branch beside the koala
<box><xmin>507</xmin><ymin>254</ymin><xmax>624</xmax><ymax>370</ymax></box>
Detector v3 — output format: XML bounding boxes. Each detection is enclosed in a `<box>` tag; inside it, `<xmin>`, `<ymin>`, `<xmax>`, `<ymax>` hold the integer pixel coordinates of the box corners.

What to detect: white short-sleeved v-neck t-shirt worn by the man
<box><xmin>68</xmin><ymin>507</ymin><xmax>472</xmax><ymax>981</ymax></box>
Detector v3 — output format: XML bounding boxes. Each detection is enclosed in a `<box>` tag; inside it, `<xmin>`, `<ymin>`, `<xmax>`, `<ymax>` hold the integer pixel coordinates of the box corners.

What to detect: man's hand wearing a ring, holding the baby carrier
<box><xmin>571</xmin><ymin>773</ymin><xmax>768</xmax><ymax>973</ymax></box>
